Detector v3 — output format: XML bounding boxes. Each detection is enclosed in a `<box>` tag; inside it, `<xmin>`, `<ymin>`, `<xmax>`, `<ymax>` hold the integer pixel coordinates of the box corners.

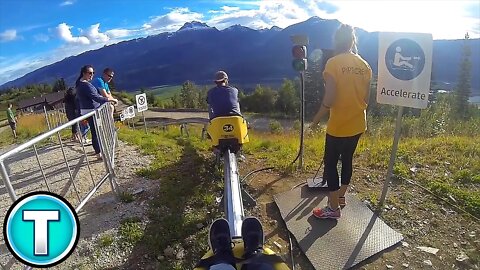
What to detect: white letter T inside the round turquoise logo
<box><xmin>23</xmin><ymin>210</ymin><xmax>60</xmax><ymax>256</ymax></box>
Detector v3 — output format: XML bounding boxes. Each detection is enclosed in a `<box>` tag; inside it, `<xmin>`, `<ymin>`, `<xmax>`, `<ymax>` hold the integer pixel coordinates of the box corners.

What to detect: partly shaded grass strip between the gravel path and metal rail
<box><xmin>120</xmin><ymin>125</ymin><xmax>219</xmax><ymax>269</ymax></box>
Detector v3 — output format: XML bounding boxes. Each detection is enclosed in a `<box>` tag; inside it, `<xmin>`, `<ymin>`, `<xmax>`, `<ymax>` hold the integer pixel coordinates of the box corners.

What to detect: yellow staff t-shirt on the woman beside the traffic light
<box><xmin>323</xmin><ymin>53</ymin><xmax>372</xmax><ymax>137</ymax></box>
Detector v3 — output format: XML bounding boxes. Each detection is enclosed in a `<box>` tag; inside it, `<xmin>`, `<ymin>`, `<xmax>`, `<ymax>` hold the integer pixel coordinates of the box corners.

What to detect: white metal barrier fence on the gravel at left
<box><xmin>0</xmin><ymin>104</ymin><xmax>119</xmax><ymax>269</ymax></box>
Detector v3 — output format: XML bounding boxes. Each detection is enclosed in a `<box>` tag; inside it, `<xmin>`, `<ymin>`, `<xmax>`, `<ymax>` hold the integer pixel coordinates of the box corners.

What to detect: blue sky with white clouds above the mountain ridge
<box><xmin>0</xmin><ymin>0</ymin><xmax>480</xmax><ymax>85</ymax></box>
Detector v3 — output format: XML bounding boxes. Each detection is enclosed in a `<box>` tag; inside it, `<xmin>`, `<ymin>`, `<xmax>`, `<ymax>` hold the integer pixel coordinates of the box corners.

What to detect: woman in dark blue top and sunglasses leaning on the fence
<box><xmin>75</xmin><ymin>65</ymin><xmax>118</xmax><ymax>159</ymax></box>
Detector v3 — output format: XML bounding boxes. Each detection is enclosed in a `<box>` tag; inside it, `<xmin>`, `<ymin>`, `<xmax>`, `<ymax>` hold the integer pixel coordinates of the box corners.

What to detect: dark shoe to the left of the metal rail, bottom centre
<box><xmin>208</xmin><ymin>218</ymin><xmax>235</xmax><ymax>265</ymax></box>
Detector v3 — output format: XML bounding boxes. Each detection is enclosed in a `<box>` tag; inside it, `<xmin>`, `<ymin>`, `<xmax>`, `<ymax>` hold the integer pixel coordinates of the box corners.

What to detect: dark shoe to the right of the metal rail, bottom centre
<box><xmin>242</xmin><ymin>217</ymin><xmax>265</xmax><ymax>258</ymax></box>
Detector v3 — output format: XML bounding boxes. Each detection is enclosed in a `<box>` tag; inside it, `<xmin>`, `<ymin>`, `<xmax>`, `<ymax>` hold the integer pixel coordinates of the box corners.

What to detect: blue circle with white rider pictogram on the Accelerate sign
<box><xmin>385</xmin><ymin>38</ymin><xmax>425</xmax><ymax>81</ymax></box>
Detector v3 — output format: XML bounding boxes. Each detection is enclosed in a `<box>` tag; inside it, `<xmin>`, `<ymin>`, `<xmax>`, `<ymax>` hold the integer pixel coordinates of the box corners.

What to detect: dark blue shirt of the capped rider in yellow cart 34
<box><xmin>207</xmin><ymin>85</ymin><xmax>242</xmax><ymax>119</ymax></box>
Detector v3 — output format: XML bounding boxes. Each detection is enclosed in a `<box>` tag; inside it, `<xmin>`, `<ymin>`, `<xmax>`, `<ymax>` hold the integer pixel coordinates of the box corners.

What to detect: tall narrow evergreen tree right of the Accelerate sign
<box><xmin>455</xmin><ymin>33</ymin><xmax>472</xmax><ymax>118</ymax></box>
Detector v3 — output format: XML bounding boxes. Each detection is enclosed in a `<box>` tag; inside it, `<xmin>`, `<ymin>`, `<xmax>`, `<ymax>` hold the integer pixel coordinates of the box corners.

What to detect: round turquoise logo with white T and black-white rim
<box><xmin>3</xmin><ymin>192</ymin><xmax>80</xmax><ymax>268</ymax></box>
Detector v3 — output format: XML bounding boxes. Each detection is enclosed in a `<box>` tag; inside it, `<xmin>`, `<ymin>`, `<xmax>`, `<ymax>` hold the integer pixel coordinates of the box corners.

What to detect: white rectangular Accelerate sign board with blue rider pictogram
<box><xmin>377</xmin><ymin>33</ymin><xmax>433</xmax><ymax>109</ymax></box>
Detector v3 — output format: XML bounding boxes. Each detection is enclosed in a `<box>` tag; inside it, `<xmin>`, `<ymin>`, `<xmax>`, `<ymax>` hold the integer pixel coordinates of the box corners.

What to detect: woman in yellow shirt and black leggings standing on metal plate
<box><xmin>311</xmin><ymin>24</ymin><xmax>372</xmax><ymax>219</ymax></box>
